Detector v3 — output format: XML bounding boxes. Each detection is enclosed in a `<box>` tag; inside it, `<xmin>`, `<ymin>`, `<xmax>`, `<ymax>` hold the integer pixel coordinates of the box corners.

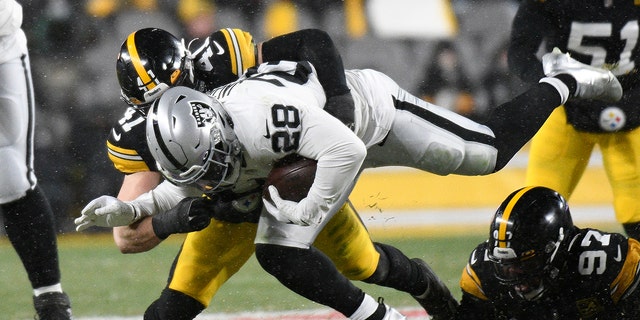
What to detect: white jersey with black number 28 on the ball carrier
<box><xmin>211</xmin><ymin>62</ymin><xmax>366</xmax><ymax>220</ymax></box>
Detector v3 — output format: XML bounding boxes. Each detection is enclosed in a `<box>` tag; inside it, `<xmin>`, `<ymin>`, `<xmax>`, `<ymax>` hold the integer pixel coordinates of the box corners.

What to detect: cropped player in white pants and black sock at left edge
<box><xmin>0</xmin><ymin>0</ymin><xmax>71</xmax><ymax>320</ymax></box>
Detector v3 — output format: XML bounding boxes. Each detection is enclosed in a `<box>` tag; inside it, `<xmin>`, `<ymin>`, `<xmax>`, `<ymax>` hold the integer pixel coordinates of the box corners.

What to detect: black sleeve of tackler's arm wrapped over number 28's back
<box><xmin>262</xmin><ymin>29</ymin><xmax>349</xmax><ymax>97</ymax></box>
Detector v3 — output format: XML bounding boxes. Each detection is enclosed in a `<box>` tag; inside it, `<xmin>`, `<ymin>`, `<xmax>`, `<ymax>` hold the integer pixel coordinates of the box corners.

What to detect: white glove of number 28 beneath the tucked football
<box><xmin>262</xmin><ymin>186</ymin><xmax>322</xmax><ymax>226</ymax></box>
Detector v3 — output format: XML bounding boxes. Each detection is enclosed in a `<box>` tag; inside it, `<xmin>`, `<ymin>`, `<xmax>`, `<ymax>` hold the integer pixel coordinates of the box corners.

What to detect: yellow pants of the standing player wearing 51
<box><xmin>526</xmin><ymin>107</ymin><xmax>640</xmax><ymax>223</ymax></box>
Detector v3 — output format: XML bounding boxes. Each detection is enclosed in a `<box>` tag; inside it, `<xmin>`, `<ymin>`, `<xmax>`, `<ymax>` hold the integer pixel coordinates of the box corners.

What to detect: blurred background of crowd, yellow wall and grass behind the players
<box><xmin>0</xmin><ymin>0</ymin><xmax>617</xmax><ymax>319</ymax></box>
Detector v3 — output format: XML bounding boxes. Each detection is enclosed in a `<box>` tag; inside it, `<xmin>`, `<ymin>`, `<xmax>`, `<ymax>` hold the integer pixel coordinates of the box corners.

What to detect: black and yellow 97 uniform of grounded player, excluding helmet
<box><xmin>457</xmin><ymin>229</ymin><xmax>640</xmax><ymax>320</ymax></box>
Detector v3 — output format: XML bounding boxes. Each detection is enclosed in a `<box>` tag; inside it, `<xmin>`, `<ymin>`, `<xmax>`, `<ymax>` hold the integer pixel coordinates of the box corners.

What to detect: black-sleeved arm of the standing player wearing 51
<box><xmin>508</xmin><ymin>0</ymin><xmax>551</xmax><ymax>83</ymax></box>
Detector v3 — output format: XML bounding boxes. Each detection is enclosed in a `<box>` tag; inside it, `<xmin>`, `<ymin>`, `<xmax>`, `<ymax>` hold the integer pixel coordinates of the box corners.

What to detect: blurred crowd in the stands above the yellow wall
<box><xmin>22</xmin><ymin>0</ymin><xmax>523</xmax><ymax>232</ymax></box>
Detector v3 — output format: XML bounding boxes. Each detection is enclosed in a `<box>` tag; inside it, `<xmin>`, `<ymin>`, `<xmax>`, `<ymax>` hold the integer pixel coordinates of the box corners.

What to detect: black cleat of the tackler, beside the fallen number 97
<box><xmin>411</xmin><ymin>258</ymin><xmax>458</xmax><ymax>320</ymax></box>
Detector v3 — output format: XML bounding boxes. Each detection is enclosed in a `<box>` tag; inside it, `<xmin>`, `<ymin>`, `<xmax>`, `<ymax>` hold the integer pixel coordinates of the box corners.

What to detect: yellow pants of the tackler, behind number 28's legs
<box><xmin>169</xmin><ymin>204</ymin><xmax>380</xmax><ymax>307</ymax></box>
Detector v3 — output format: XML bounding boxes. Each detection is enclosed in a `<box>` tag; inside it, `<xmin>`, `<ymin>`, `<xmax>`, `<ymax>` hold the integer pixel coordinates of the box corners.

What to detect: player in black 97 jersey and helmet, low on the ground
<box><xmin>457</xmin><ymin>186</ymin><xmax>640</xmax><ymax>320</ymax></box>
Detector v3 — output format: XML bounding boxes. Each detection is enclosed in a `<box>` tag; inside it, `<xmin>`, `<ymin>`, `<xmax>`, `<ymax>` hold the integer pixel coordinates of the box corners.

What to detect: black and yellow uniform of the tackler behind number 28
<box><xmin>107</xmin><ymin>29</ymin><xmax>382</xmax><ymax>310</ymax></box>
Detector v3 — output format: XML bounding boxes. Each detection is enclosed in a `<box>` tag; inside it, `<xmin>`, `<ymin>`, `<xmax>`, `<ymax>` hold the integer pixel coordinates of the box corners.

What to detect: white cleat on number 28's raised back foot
<box><xmin>542</xmin><ymin>48</ymin><xmax>622</xmax><ymax>102</ymax></box>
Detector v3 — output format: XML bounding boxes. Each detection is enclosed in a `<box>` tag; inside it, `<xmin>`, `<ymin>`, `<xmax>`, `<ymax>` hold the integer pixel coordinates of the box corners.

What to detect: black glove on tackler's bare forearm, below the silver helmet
<box><xmin>151</xmin><ymin>198</ymin><xmax>212</xmax><ymax>239</ymax></box>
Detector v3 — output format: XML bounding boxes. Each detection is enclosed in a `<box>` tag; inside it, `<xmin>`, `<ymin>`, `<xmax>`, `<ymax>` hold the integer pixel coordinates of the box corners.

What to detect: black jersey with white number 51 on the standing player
<box><xmin>509</xmin><ymin>0</ymin><xmax>640</xmax><ymax>132</ymax></box>
